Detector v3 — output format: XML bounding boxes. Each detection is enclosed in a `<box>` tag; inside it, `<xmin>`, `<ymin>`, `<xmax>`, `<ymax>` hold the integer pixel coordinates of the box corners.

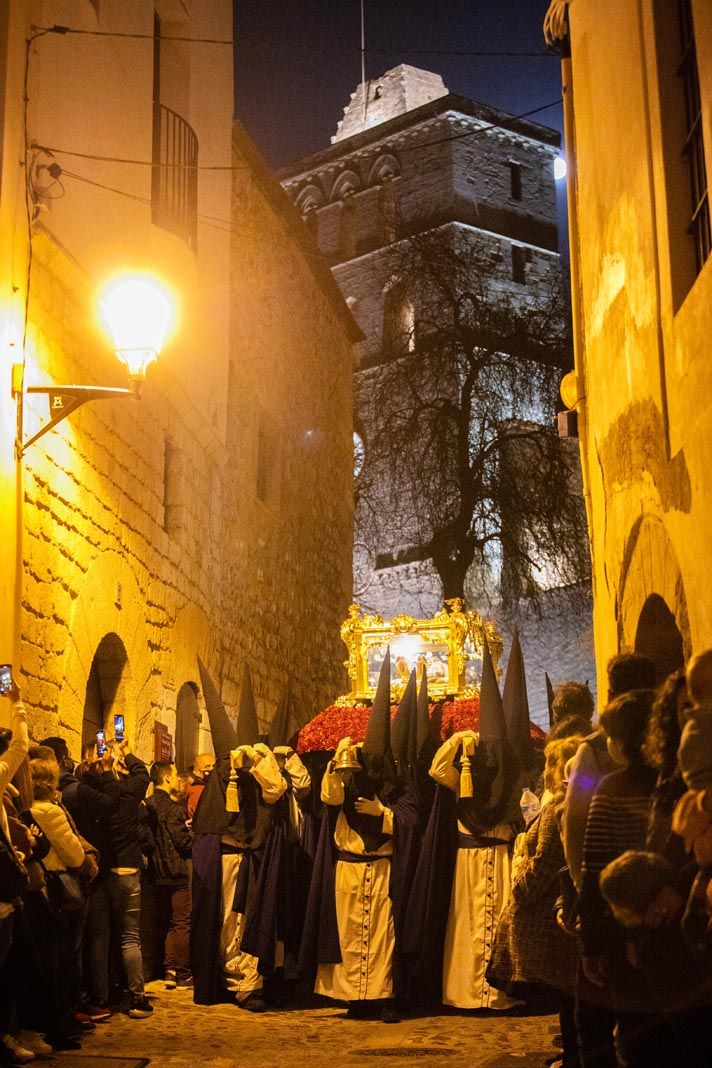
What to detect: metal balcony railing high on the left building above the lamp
<box><xmin>151</xmin><ymin>101</ymin><xmax>197</xmax><ymax>251</ymax></box>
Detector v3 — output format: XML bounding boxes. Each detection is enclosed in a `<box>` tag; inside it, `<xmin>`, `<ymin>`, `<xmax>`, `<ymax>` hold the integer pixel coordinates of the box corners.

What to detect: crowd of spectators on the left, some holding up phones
<box><xmin>0</xmin><ymin>690</ymin><xmax>207</xmax><ymax>1065</ymax></box>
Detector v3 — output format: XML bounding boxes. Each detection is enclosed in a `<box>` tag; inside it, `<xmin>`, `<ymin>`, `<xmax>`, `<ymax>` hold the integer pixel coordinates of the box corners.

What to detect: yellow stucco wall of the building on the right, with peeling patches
<box><xmin>568</xmin><ymin>0</ymin><xmax>712</xmax><ymax>692</ymax></box>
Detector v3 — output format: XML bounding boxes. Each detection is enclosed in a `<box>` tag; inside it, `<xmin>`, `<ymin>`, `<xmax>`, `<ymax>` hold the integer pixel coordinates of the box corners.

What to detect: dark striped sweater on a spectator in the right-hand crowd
<box><xmin>579</xmin><ymin>765</ymin><xmax>656</xmax><ymax>957</ymax></box>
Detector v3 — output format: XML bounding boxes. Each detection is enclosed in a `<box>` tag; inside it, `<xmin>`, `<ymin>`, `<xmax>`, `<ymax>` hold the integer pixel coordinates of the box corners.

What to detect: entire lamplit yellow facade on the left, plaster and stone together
<box><xmin>0</xmin><ymin>0</ymin><xmax>354</xmax><ymax>758</ymax></box>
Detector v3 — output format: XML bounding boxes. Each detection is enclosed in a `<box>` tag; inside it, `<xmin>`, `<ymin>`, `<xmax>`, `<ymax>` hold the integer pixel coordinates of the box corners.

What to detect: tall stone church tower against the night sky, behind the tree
<box><xmin>280</xmin><ymin>64</ymin><xmax>595</xmax><ymax>718</ymax></box>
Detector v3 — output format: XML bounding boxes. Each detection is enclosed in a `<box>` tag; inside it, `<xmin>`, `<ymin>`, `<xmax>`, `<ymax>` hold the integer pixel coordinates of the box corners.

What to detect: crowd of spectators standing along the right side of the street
<box><xmin>488</xmin><ymin>651</ymin><xmax>712</xmax><ymax>1068</ymax></box>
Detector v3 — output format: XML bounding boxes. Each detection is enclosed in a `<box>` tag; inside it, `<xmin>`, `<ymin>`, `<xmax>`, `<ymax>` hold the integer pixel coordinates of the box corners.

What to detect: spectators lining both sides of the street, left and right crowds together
<box><xmin>0</xmin><ymin>650</ymin><xmax>712</xmax><ymax>1068</ymax></box>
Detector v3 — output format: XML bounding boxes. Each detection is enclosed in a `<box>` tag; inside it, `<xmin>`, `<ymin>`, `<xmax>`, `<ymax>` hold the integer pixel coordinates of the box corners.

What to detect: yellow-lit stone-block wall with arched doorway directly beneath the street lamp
<box><xmin>20</xmin><ymin>231</ymin><xmax>222</xmax><ymax>756</ymax></box>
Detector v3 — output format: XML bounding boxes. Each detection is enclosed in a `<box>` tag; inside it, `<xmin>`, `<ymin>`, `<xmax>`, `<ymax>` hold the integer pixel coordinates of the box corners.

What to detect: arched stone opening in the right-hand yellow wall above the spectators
<box><xmin>617</xmin><ymin>515</ymin><xmax>692</xmax><ymax>678</ymax></box>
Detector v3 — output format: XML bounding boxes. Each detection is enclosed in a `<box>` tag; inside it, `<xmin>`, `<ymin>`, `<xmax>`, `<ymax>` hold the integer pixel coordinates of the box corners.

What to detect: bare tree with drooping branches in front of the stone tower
<box><xmin>357</xmin><ymin>226</ymin><xmax>589</xmax><ymax>606</ymax></box>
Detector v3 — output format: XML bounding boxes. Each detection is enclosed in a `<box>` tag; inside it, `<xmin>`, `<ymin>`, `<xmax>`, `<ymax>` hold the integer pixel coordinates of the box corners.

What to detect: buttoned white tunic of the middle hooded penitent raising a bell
<box><xmin>314</xmin><ymin>768</ymin><xmax>395</xmax><ymax>1001</ymax></box>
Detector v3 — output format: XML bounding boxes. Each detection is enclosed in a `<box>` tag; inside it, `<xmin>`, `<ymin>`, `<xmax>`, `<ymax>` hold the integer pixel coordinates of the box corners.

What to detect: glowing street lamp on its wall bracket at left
<box><xmin>13</xmin><ymin>274</ymin><xmax>175</xmax><ymax>458</ymax></box>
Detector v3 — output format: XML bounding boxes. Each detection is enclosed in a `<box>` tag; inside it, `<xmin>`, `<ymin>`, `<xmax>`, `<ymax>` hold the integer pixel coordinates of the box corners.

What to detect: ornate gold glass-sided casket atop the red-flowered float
<box><xmin>337</xmin><ymin>597</ymin><xmax>502</xmax><ymax>705</ymax></box>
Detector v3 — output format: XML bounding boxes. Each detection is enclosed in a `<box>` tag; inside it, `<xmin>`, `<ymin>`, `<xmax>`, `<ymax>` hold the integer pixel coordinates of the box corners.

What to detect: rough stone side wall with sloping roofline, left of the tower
<box><xmin>219</xmin><ymin>127</ymin><xmax>353</xmax><ymax>722</ymax></box>
